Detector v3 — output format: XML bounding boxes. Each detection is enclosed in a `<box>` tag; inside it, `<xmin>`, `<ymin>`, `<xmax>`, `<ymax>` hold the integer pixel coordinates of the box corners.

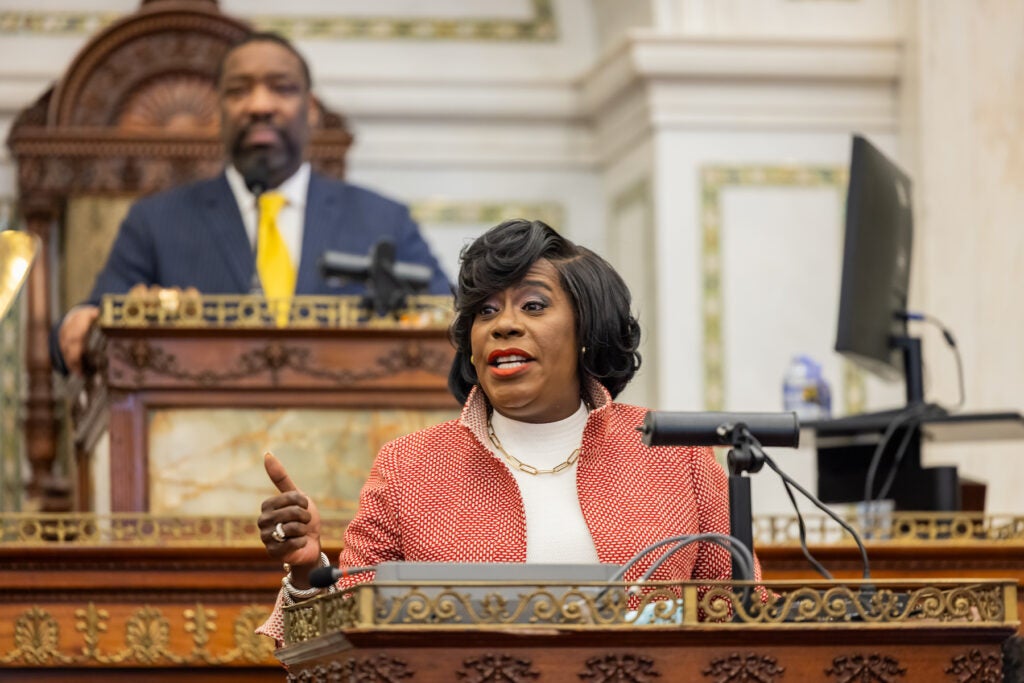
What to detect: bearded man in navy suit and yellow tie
<box><xmin>50</xmin><ymin>33</ymin><xmax>452</xmax><ymax>374</ymax></box>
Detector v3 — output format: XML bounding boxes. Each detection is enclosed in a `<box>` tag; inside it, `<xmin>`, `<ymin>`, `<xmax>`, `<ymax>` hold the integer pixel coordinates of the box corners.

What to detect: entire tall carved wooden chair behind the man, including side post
<box><xmin>7</xmin><ymin>0</ymin><xmax>352</xmax><ymax>510</ymax></box>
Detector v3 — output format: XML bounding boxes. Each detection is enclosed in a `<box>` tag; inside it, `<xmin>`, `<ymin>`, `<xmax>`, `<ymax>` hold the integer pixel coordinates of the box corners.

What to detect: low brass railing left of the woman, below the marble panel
<box><xmin>0</xmin><ymin>512</ymin><xmax>348</xmax><ymax>548</ymax></box>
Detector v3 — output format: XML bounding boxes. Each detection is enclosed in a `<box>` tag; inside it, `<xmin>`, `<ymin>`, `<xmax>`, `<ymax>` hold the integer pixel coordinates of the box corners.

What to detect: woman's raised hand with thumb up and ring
<box><xmin>257</xmin><ymin>453</ymin><xmax>321</xmax><ymax>583</ymax></box>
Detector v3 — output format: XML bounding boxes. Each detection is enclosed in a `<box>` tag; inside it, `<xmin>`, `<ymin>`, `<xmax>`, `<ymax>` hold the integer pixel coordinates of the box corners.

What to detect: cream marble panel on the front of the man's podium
<box><xmin>148</xmin><ymin>409</ymin><xmax>458</xmax><ymax>515</ymax></box>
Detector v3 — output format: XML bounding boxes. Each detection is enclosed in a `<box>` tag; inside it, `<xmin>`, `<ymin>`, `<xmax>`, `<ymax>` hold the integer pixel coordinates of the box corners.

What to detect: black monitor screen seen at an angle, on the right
<box><xmin>836</xmin><ymin>135</ymin><xmax>921</xmax><ymax>389</ymax></box>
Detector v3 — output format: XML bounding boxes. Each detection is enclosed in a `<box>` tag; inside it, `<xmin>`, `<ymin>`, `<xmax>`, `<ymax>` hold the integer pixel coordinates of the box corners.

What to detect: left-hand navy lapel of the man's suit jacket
<box><xmin>200</xmin><ymin>173</ymin><xmax>255</xmax><ymax>294</ymax></box>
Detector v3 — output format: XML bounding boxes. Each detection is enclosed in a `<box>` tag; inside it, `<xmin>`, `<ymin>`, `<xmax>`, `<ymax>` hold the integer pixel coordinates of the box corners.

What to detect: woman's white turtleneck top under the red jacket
<box><xmin>486</xmin><ymin>401</ymin><xmax>599</xmax><ymax>564</ymax></box>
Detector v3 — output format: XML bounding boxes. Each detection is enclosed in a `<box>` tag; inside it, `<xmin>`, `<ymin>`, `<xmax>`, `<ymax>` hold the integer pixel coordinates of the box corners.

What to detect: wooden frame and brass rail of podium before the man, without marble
<box><xmin>73</xmin><ymin>290</ymin><xmax>458</xmax><ymax>514</ymax></box>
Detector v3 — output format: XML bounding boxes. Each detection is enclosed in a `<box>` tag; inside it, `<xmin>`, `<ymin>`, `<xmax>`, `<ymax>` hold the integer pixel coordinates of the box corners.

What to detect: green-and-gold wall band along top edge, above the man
<box><xmin>0</xmin><ymin>0</ymin><xmax>558</xmax><ymax>43</ymax></box>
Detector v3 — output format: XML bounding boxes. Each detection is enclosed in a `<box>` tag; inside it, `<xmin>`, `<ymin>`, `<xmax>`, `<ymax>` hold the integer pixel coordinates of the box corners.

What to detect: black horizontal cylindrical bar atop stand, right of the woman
<box><xmin>637</xmin><ymin>411</ymin><xmax>800</xmax><ymax>449</ymax></box>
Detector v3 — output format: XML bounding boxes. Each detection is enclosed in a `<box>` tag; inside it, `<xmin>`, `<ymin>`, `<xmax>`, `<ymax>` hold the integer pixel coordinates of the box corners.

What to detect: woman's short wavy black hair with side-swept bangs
<box><xmin>449</xmin><ymin>219</ymin><xmax>640</xmax><ymax>402</ymax></box>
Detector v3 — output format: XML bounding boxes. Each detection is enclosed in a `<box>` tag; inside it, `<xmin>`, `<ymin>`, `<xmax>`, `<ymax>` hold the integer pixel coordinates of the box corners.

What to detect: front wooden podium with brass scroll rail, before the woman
<box><xmin>276</xmin><ymin>582</ymin><xmax>1018</xmax><ymax>683</ymax></box>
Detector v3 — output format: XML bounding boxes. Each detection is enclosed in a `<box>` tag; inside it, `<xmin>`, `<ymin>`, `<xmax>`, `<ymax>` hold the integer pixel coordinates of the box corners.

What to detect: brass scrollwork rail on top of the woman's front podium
<box><xmin>285</xmin><ymin>580</ymin><xmax>1017</xmax><ymax>644</ymax></box>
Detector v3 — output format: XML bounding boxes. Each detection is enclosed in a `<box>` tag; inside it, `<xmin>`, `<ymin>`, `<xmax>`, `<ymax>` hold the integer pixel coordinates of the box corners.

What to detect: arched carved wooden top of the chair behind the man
<box><xmin>7</xmin><ymin>0</ymin><xmax>352</xmax><ymax>212</ymax></box>
